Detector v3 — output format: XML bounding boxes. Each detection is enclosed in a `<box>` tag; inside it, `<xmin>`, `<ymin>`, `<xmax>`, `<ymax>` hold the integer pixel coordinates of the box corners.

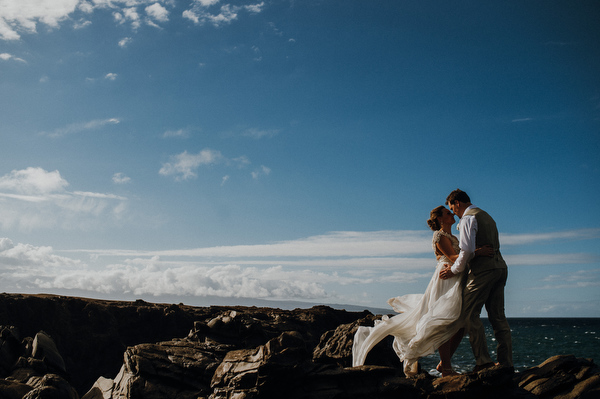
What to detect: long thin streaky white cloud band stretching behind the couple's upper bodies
<box><xmin>58</xmin><ymin>228</ymin><xmax>598</xmax><ymax>278</ymax></box>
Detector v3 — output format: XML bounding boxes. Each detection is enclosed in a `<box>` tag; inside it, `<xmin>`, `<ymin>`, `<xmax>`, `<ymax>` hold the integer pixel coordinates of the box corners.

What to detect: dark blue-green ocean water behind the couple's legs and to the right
<box><xmin>419</xmin><ymin>318</ymin><xmax>600</xmax><ymax>376</ymax></box>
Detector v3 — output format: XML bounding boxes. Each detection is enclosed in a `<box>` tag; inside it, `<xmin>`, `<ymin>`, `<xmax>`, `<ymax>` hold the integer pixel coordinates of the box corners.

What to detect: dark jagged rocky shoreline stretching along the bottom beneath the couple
<box><xmin>0</xmin><ymin>294</ymin><xmax>600</xmax><ymax>399</ymax></box>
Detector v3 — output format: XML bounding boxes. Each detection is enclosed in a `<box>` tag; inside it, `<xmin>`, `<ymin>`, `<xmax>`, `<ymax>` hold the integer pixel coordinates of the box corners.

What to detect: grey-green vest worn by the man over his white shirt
<box><xmin>463</xmin><ymin>208</ymin><xmax>506</xmax><ymax>274</ymax></box>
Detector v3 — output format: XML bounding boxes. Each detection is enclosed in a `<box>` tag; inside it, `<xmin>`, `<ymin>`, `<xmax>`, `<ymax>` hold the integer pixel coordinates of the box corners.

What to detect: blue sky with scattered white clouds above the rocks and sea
<box><xmin>0</xmin><ymin>0</ymin><xmax>600</xmax><ymax>317</ymax></box>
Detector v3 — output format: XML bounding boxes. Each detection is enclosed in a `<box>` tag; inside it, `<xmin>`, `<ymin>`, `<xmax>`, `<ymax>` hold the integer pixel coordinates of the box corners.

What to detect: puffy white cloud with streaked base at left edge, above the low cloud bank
<box><xmin>0</xmin><ymin>168</ymin><xmax>127</xmax><ymax>231</ymax></box>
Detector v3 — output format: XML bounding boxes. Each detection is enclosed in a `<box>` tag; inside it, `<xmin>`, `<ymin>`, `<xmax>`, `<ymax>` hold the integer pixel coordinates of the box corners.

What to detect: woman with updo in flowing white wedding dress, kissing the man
<box><xmin>352</xmin><ymin>206</ymin><xmax>493</xmax><ymax>377</ymax></box>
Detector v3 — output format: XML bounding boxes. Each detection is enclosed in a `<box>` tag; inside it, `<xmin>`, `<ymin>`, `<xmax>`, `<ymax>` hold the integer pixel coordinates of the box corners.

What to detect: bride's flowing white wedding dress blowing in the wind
<box><xmin>352</xmin><ymin>230</ymin><xmax>464</xmax><ymax>376</ymax></box>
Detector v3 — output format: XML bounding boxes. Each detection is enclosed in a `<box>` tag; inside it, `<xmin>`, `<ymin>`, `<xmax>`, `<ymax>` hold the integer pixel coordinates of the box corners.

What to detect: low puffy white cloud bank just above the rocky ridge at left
<box><xmin>0</xmin><ymin>238</ymin><xmax>330</xmax><ymax>300</ymax></box>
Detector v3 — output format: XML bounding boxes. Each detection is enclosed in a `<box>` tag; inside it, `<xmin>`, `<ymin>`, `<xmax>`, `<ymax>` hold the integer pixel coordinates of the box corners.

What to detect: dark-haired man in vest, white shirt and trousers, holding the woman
<box><xmin>440</xmin><ymin>189</ymin><xmax>513</xmax><ymax>371</ymax></box>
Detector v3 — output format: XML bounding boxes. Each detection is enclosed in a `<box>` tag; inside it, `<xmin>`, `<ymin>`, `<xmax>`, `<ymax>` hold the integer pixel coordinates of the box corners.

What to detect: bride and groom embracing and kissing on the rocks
<box><xmin>352</xmin><ymin>189</ymin><xmax>513</xmax><ymax>376</ymax></box>
